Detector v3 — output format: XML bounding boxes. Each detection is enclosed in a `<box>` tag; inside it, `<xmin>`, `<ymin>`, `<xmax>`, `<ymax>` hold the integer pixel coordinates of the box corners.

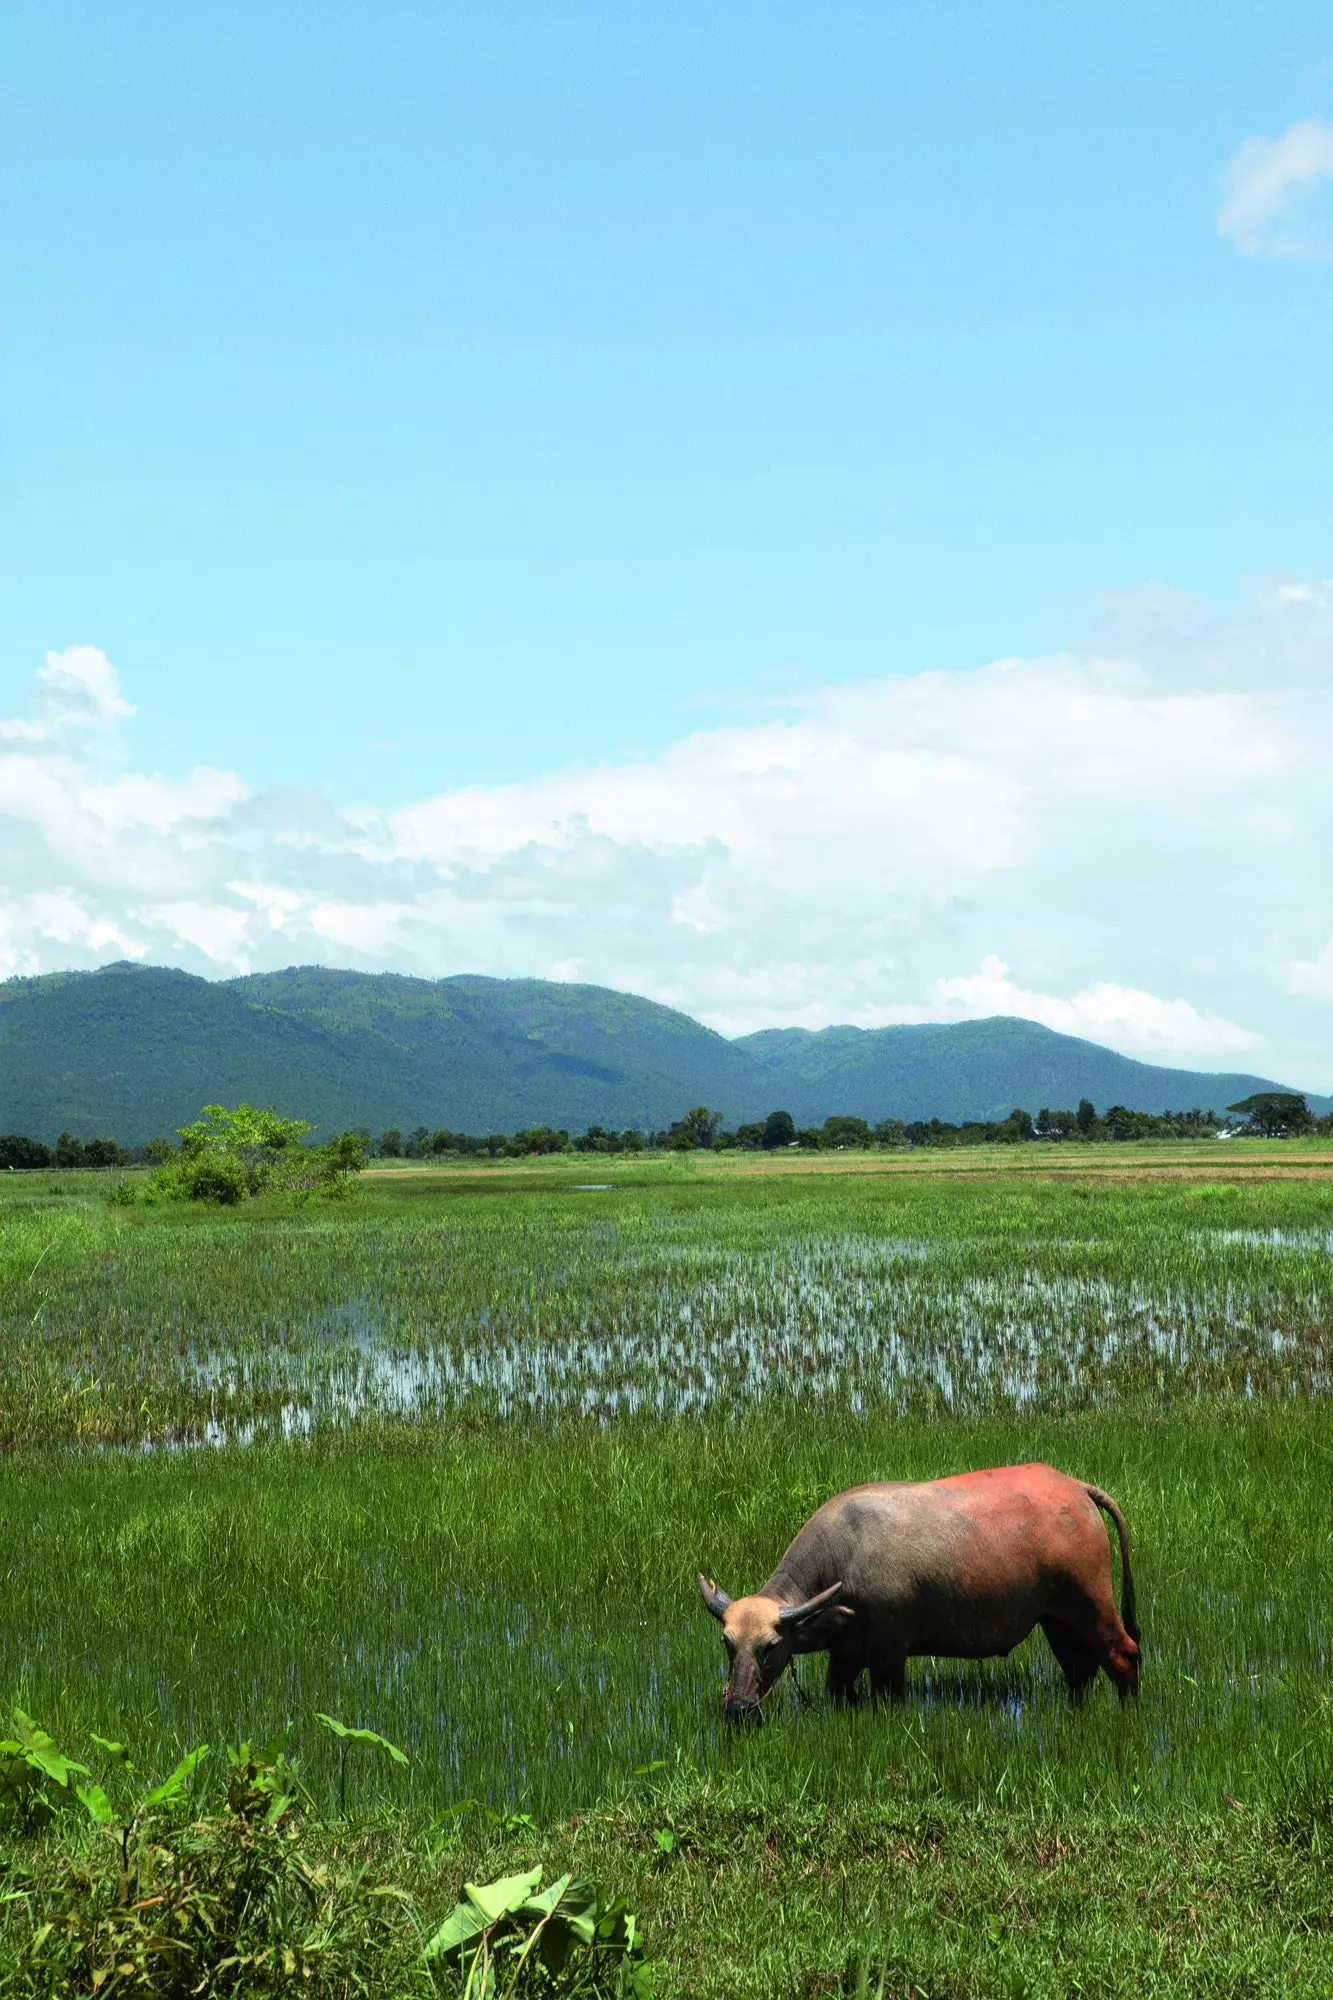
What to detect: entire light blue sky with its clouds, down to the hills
<box><xmin>0</xmin><ymin>0</ymin><xmax>1333</xmax><ymax>1086</ymax></box>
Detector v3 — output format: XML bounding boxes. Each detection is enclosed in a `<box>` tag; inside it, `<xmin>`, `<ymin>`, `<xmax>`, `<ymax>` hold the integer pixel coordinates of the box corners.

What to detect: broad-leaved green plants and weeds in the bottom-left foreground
<box><xmin>0</xmin><ymin>1710</ymin><xmax>652</xmax><ymax>2000</ymax></box>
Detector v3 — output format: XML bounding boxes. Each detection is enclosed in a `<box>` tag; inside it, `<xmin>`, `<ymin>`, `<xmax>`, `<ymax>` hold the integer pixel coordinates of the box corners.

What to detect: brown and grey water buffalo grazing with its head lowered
<box><xmin>699</xmin><ymin>1466</ymin><xmax>1139</xmax><ymax>1722</ymax></box>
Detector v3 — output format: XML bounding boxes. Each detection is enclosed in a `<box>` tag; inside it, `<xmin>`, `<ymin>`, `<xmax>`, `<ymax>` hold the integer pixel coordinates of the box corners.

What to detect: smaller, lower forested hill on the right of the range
<box><xmin>735</xmin><ymin>1014</ymin><xmax>1325</xmax><ymax>1124</ymax></box>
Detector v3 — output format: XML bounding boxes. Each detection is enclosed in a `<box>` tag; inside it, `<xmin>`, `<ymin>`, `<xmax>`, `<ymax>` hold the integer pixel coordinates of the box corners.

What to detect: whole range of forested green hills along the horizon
<box><xmin>0</xmin><ymin>964</ymin><xmax>1327</xmax><ymax>1146</ymax></box>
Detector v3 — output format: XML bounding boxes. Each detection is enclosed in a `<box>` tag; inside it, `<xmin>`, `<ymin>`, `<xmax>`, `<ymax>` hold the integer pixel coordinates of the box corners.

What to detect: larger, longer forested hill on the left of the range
<box><xmin>0</xmin><ymin>966</ymin><xmax>773</xmax><ymax>1146</ymax></box>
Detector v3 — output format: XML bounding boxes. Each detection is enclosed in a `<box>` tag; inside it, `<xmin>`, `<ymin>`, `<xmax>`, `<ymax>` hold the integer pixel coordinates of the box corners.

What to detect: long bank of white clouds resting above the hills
<box><xmin>0</xmin><ymin>580</ymin><xmax>1333</xmax><ymax>1088</ymax></box>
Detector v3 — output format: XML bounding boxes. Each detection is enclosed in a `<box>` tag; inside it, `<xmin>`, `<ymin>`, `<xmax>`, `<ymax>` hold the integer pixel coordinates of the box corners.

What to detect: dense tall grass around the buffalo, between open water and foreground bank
<box><xmin>0</xmin><ymin>1406</ymin><xmax>1333</xmax><ymax>1816</ymax></box>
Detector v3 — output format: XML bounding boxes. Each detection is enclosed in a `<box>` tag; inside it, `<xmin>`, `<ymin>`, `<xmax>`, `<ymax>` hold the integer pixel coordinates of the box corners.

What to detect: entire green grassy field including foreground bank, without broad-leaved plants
<box><xmin>0</xmin><ymin>1146</ymin><xmax>1333</xmax><ymax>2000</ymax></box>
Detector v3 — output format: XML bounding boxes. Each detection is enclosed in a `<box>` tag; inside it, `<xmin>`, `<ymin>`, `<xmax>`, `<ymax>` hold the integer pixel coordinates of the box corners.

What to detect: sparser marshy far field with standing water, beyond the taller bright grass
<box><xmin>0</xmin><ymin>1184</ymin><xmax>1333</xmax><ymax>1442</ymax></box>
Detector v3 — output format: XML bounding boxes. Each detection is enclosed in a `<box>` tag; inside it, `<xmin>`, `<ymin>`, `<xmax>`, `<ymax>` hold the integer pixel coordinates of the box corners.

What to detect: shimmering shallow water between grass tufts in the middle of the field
<box><xmin>163</xmin><ymin>1228</ymin><xmax>1333</xmax><ymax>1440</ymax></box>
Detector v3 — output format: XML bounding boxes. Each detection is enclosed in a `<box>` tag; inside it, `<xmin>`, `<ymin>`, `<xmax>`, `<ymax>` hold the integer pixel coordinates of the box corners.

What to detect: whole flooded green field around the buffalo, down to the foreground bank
<box><xmin>0</xmin><ymin>1168</ymin><xmax>1333</xmax><ymax>1812</ymax></box>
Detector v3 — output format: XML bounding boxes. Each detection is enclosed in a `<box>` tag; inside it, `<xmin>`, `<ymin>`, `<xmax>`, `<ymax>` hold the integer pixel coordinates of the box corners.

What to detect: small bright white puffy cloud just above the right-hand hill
<box><xmin>935</xmin><ymin>956</ymin><xmax>1263</xmax><ymax>1056</ymax></box>
